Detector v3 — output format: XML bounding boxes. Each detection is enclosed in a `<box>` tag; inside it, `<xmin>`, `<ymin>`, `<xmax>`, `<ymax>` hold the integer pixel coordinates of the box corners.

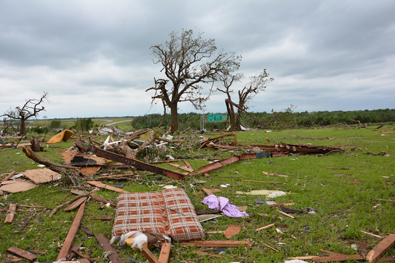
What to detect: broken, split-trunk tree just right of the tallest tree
<box><xmin>217</xmin><ymin>69</ymin><xmax>274</xmax><ymax>130</ymax></box>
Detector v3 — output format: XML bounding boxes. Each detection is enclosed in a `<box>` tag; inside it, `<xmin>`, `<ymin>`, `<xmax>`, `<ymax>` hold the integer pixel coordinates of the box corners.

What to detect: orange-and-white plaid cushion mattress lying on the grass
<box><xmin>112</xmin><ymin>189</ymin><xmax>205</xmax><ymax>242</ymax></box>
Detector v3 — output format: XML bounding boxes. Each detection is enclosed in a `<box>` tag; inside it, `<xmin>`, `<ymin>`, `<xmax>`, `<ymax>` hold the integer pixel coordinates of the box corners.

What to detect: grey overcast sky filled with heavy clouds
<box><xmin>0</xmin><ymin>0</ymin><xmax>395</xmax><ymax>118</ymax></box>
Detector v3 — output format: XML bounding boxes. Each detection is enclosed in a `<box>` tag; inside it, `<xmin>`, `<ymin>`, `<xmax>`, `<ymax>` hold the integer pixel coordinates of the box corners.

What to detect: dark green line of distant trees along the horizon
<box><xmin>131</xmin><ymin>106</ymin><xmax>395</xmax><ymax>131</ymax></box>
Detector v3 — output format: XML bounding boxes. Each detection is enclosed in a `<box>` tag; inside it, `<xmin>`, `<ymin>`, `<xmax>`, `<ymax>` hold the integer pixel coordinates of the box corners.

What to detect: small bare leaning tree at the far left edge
<box><xmin>0</xmin><ymin>92</ymin><xmax>48</xmax><ymax>135</ymax></box>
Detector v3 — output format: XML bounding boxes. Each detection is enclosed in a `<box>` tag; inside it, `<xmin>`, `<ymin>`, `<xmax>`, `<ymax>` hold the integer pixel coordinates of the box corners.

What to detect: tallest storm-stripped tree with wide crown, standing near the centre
<box><xmin>146</xmin><ymin>30</ymin><xmax>241</xmax><ymax>133</ymax></box>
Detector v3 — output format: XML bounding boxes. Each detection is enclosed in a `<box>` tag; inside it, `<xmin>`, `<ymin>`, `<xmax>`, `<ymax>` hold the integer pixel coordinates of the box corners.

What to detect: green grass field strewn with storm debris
<box><xmin>0</xmin><ymin>123</ymin><xmax>395</xmax><ymax>262</ymax></box>
